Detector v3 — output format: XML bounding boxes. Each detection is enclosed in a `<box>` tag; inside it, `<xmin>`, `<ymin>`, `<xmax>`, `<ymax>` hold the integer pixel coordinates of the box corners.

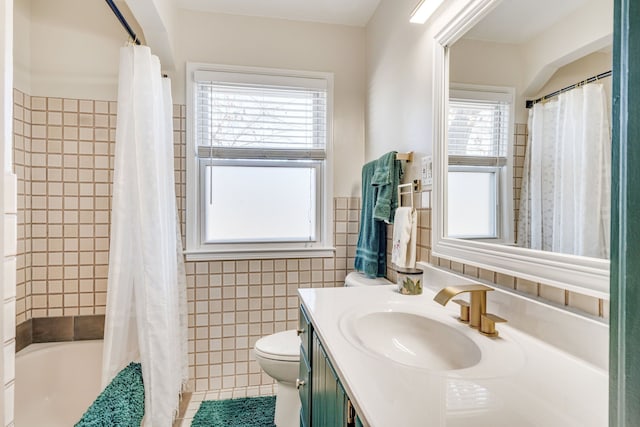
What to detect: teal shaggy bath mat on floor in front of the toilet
<box><xmin>191</xmin><ymin>396</ymin><xmax>276</xmax><ymax>427</ymax></box>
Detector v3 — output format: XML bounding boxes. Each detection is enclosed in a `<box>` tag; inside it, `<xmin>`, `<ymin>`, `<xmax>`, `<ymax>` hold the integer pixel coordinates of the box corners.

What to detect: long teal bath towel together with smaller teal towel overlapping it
<box><xmin>355</xmin><ymin>151</ymin><xmax>403</xmax><ymax>277</ymax></box>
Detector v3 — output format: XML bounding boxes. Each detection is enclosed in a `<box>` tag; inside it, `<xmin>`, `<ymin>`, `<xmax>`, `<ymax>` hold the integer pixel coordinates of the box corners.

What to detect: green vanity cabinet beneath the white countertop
<box><xmin>298</xmin><ymin>307</ymin><xmax>362</xmax><ymax>427</ymax></box>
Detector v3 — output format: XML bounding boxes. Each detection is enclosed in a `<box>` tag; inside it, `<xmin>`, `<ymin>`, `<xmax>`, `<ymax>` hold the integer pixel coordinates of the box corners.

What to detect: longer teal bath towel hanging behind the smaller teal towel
<box><xmin>355</xmin><ymin>161</ymin><xmax>387</xmax><ymax>277</ymax></box>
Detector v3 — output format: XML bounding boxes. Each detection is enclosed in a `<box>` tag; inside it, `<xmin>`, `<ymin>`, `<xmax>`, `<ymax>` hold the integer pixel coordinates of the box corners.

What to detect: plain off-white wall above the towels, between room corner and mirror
<box><xmin>366</xmin><ymin>0</ymin><xmax>450</xmax><ymax>169</ymax></box>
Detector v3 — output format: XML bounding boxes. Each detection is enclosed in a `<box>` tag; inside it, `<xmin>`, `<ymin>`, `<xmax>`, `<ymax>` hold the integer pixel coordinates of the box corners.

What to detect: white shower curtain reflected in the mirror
<box><xmin>518</xmin><ymin>84</ymin><xmax>611</xmax><ymax>258</ymax></box>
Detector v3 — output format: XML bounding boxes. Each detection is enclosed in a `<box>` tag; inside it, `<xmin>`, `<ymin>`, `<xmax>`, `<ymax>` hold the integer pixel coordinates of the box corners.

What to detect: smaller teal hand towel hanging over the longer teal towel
<box><xmin>372</xmin><ymin>151</ymin><xmax>404</xmax><ymax>224</ymax></box>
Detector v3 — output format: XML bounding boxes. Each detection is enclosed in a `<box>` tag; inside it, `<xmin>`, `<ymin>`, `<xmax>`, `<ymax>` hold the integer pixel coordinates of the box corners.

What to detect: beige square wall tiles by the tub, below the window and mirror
<box><xmin>14</xmin><ymin>91</ymin><xmax>608</xmax><ymax>398</ymax></box>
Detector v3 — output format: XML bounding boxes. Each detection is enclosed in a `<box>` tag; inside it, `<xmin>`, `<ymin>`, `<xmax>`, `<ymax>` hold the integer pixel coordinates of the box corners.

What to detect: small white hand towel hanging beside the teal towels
<box><xmin>391</xmin><ymin>207</ymin><xmax>418</xmax><ymax>268</ymax></box>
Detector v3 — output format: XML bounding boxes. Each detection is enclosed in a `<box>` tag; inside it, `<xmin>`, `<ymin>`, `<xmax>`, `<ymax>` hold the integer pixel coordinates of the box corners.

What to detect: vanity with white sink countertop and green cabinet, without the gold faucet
<box><xmin>298</xmin><ymin>265</ymin><xmax>608</xmax><ymax>427</ymax></box>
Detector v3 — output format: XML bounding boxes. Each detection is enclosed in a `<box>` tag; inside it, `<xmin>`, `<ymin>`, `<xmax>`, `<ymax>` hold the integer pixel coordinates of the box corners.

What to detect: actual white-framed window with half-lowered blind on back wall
<box><xmin>187</xmin><ymin>64</ymin><xmax>333</xmax><ymax>259</ymax></box>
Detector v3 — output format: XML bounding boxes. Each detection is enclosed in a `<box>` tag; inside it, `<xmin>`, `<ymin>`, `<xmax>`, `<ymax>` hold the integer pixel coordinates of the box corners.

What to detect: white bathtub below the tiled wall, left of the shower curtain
<box><xmin>15</xmin><ymin>340</ymin><xmax>102</xmax><ymax>427</ymax></box>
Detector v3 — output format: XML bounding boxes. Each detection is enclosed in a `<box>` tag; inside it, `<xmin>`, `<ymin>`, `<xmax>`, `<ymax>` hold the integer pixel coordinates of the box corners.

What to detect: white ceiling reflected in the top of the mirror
<box><xmin>464</xmin><ymin>0</ymin><xmax>590</xmax><ymax>44</ymax></box>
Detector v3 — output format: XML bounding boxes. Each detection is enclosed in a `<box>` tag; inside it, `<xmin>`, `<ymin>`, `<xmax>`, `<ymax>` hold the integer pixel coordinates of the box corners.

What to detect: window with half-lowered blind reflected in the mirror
<box><xmin>447</xmin><ymin>87</ymin><xmax>513</xmax><ymax>243</ymax></box>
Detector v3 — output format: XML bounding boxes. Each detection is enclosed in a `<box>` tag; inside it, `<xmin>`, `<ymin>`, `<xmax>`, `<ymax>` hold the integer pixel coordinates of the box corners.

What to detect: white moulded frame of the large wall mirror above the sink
<box><xmin>431</xmin><ymin>0</ymin><xmax>610</xmax><ymax>300</ymax></box>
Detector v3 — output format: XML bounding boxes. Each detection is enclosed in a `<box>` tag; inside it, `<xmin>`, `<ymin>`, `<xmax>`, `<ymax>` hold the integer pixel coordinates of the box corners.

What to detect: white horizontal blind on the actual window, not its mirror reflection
<box><xmin>196</xmin><ymin>81</ymin><xmax>327</xmax><ymax>158</ymax></box>
